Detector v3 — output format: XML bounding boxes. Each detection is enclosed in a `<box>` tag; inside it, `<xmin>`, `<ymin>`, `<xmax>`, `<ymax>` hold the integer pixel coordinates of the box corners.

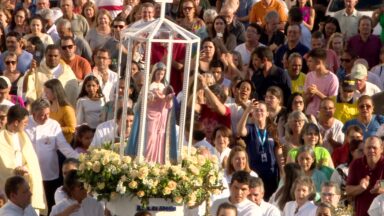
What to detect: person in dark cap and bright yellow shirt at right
<box><xmin>334</xmin><ymin>78</ymin><xmax>359</xmax><ymax>124</ymax></box>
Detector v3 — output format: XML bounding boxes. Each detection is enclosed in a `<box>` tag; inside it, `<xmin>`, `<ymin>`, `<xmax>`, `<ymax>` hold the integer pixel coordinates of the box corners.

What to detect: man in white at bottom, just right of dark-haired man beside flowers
<box><xmin>248</xmin><ymin>177</ymin><xmax>281</xmax><ymax>216</ymax></box>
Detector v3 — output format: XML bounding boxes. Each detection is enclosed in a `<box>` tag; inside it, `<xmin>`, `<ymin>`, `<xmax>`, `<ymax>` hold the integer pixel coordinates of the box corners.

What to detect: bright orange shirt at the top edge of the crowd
<box><xmin>249</xmin><ymin>0</ymin><xmax>288</xmax><ymax>26</ymax></box>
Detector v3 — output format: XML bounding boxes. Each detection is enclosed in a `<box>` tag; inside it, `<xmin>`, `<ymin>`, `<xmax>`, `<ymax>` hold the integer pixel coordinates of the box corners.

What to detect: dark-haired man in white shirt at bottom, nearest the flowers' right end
<box><xmin>211</xmin><ymin>171</ymin><xmax>263</xmax><ymax>216</ymax></box>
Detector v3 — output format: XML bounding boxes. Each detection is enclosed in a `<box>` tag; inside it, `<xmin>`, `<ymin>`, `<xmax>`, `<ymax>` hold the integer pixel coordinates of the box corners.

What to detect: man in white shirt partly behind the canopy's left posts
<box><xmin>91</xmin><ymin>108</ymin><xmax>134</xmax><ymax>148</ymax></box>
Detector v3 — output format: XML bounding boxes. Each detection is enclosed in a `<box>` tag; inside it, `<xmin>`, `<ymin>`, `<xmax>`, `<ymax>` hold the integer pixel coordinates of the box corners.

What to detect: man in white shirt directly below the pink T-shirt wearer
<box><xmin>318</xmin><ymin>97</ymin><xmax>344</xmax><ymax>154</ymax></box>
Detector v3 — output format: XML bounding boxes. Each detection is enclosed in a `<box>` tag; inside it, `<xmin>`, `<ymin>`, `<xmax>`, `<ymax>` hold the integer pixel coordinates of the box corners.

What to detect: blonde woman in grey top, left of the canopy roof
<box><xmin>85</xmin><ymin>9</ymin><xmax>112</xmax><ymax>50</ymax></box>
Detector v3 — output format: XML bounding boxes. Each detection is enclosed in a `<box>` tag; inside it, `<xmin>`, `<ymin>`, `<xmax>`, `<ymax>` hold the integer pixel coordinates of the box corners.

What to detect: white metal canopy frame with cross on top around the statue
<box><xmin>115</xmin><ymin>0</ymin><xmax>200</xmax><ymax>163</ymax></box>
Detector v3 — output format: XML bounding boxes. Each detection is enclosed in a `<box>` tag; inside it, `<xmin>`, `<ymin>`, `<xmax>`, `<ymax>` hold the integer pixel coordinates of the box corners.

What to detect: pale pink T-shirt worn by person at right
<box><xmin>304</xmin><ymin>71</ymin><xmax>339</xmax><ymax>116</ymax></box>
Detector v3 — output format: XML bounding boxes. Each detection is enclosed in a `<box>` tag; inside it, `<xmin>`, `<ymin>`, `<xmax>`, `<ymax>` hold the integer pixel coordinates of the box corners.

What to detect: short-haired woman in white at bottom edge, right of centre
<box><xmin>282</xmin><ymin>176</ymin><xmax>316</xmax><ymax>216</ymax></box>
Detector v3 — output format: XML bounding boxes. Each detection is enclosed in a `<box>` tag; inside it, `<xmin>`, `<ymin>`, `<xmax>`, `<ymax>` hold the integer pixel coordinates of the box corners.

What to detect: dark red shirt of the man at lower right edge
<box><xmin>347</xmin><ymin>156</ymin><xmax>384</xmax><ymax>216</ymax></box>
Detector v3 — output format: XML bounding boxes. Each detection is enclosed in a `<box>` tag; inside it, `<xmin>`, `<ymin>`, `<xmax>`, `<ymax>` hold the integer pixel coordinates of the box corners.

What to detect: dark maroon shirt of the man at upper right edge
<box><xmin>348</xmin><ymin>34</ymin><xmax>381</xmax><ymax>68</ymax></box>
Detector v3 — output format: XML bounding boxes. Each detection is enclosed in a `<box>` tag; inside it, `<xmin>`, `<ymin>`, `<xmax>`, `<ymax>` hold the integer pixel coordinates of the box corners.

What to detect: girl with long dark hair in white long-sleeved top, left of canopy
<box><xmin>76</xmin><ymin>75</ymin><xmax>105</xmax><ymax>129</ymax></box>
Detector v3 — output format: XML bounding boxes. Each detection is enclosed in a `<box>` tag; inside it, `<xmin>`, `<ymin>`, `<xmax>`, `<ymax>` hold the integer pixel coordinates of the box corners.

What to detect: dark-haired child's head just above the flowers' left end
<box><xmin>73</xmin><ymin>125</ymin><xmax>94</xmax><ymax>153</ymax></box>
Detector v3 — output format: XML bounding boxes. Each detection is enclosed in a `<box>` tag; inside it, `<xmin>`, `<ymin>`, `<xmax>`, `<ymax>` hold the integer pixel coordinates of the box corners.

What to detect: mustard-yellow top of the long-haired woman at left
<box><xmin>49</xmin><ymin>106</ymin><xmax>77</xmax><ymax>143</ymax></box>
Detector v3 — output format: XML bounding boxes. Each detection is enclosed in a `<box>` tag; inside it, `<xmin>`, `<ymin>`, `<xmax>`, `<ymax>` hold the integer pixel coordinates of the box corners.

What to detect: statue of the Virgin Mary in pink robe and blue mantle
<box><xmin>125</xmin><ymin>62</ymin><xmax>178</xmax><ymax>164</ymax></box>
